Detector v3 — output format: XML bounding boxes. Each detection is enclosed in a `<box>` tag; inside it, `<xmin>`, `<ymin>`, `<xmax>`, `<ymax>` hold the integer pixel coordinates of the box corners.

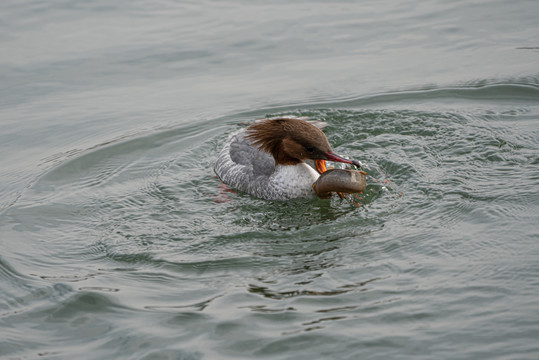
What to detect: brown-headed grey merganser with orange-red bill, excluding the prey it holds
<box><xmin>215</xmin><ymin>117</ymin><xmax>361</xmax><ymax>200</ymax></box>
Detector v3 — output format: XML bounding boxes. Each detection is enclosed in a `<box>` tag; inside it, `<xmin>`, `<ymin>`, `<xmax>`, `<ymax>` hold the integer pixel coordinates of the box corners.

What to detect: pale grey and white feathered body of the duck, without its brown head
<box><xmin>215</xmin><ymin>129</ymin><xmax>320</xmax><ymax>200</ymax></box>
